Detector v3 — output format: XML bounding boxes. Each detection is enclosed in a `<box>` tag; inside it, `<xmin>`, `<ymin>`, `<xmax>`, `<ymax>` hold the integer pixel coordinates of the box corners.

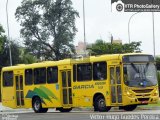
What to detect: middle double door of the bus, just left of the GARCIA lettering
<box><xmin>61</xmin><ymin>70</ymin><xmax>72</xmax><ymax>107</ymax></box>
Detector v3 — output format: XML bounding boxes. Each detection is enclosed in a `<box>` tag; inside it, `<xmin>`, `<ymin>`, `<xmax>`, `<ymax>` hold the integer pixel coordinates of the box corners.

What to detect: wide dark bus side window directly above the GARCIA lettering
<box><xmin>77</xmin><ymin>63</ymin><xmax>92</xmax><ymax>81</ymax></box>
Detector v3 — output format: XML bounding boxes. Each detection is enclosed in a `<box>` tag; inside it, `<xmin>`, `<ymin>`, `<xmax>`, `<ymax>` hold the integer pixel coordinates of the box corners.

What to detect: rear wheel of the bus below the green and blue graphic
<box><xmin>32</xmin><ymin>97</ymin><xmax>48</xmax><ymax>113</ymax></box>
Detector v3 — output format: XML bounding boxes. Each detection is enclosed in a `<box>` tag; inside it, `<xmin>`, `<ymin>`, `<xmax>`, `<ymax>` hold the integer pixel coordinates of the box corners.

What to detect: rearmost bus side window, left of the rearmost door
<box><xmin>3</xmin><ymin>71</ymin><xmax>13</xmax><ymax>87</ymax></box>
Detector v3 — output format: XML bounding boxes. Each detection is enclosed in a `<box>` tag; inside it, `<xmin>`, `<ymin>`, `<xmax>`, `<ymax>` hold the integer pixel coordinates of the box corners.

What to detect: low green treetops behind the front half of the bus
<box><xmin>87</xmin><ymin>40</ymin><xmax>141</xmax><ymax>55</ymax></box>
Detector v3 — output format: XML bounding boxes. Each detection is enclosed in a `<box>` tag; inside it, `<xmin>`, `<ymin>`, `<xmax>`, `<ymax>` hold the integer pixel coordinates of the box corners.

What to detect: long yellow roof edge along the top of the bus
<box><xmin>2</xmin><ymin>53</ymin><xmax>150</xmax><ymax>71</ymax></box>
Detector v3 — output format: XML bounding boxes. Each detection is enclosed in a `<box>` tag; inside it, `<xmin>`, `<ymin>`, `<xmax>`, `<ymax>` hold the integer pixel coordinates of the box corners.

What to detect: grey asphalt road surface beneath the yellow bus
<box><xmin>0</xmin><ymin>110</ymin><xmax>160</xmax><ymax>120</ymax></box>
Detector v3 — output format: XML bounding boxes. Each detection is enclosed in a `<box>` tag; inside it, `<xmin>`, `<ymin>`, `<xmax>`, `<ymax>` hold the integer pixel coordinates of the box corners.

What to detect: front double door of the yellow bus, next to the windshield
<box><xmin>109</xmin><ymin>65</ymin><xmax>122</xmax><ymax>105</ymax></box>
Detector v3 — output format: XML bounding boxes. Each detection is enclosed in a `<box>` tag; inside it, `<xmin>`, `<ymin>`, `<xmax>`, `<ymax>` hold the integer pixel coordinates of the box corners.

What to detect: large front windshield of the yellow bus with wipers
<box><xmin>123</xmin><ymin>63</ymin><xmax>157</xmax><ymax>87</ymax></box>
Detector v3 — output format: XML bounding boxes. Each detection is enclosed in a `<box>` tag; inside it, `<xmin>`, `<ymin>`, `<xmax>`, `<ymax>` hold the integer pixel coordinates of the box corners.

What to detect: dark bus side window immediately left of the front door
<box><xmin>93</xmin><ymin>62</ymin><xmax>107</xmax><ymax>80</ymax></box>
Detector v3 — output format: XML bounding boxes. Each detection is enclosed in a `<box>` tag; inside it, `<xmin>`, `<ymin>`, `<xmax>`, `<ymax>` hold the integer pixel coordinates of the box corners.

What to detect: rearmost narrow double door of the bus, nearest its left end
<box><xmin>14</xmin><ymin>74</ymin><xmax>24</xmax><ymax>107</ymax></box>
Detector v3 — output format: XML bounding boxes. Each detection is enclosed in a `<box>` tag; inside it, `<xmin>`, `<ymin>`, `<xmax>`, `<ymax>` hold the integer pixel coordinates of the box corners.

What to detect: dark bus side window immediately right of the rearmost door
<box><xmin>25</xmin><ymin>69</ymin><xmax>33</xmax><ymax>85</ymax></box>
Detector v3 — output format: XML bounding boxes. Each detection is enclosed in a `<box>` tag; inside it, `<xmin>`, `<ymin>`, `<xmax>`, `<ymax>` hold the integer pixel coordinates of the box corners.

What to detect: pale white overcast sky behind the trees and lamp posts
<box><xmin>0</xmin><ymin>0</ymin><xmax>160</xmax><ymax>55</ymax></box>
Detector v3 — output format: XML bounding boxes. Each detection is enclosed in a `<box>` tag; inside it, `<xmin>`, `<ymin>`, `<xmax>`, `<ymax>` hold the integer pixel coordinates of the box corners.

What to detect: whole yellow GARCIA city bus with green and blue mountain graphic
<box><xmin>1</xmin><ymin>53</ymin><xmax>159</xmax><ymax>113</ymax></box>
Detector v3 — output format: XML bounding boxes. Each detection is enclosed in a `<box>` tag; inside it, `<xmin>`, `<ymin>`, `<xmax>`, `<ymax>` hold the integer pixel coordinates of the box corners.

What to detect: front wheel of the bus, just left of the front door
<box><xmin>94</xmin><ymin>95</ymin><xmax>111</xmax><ymax>112</ymax></box>
